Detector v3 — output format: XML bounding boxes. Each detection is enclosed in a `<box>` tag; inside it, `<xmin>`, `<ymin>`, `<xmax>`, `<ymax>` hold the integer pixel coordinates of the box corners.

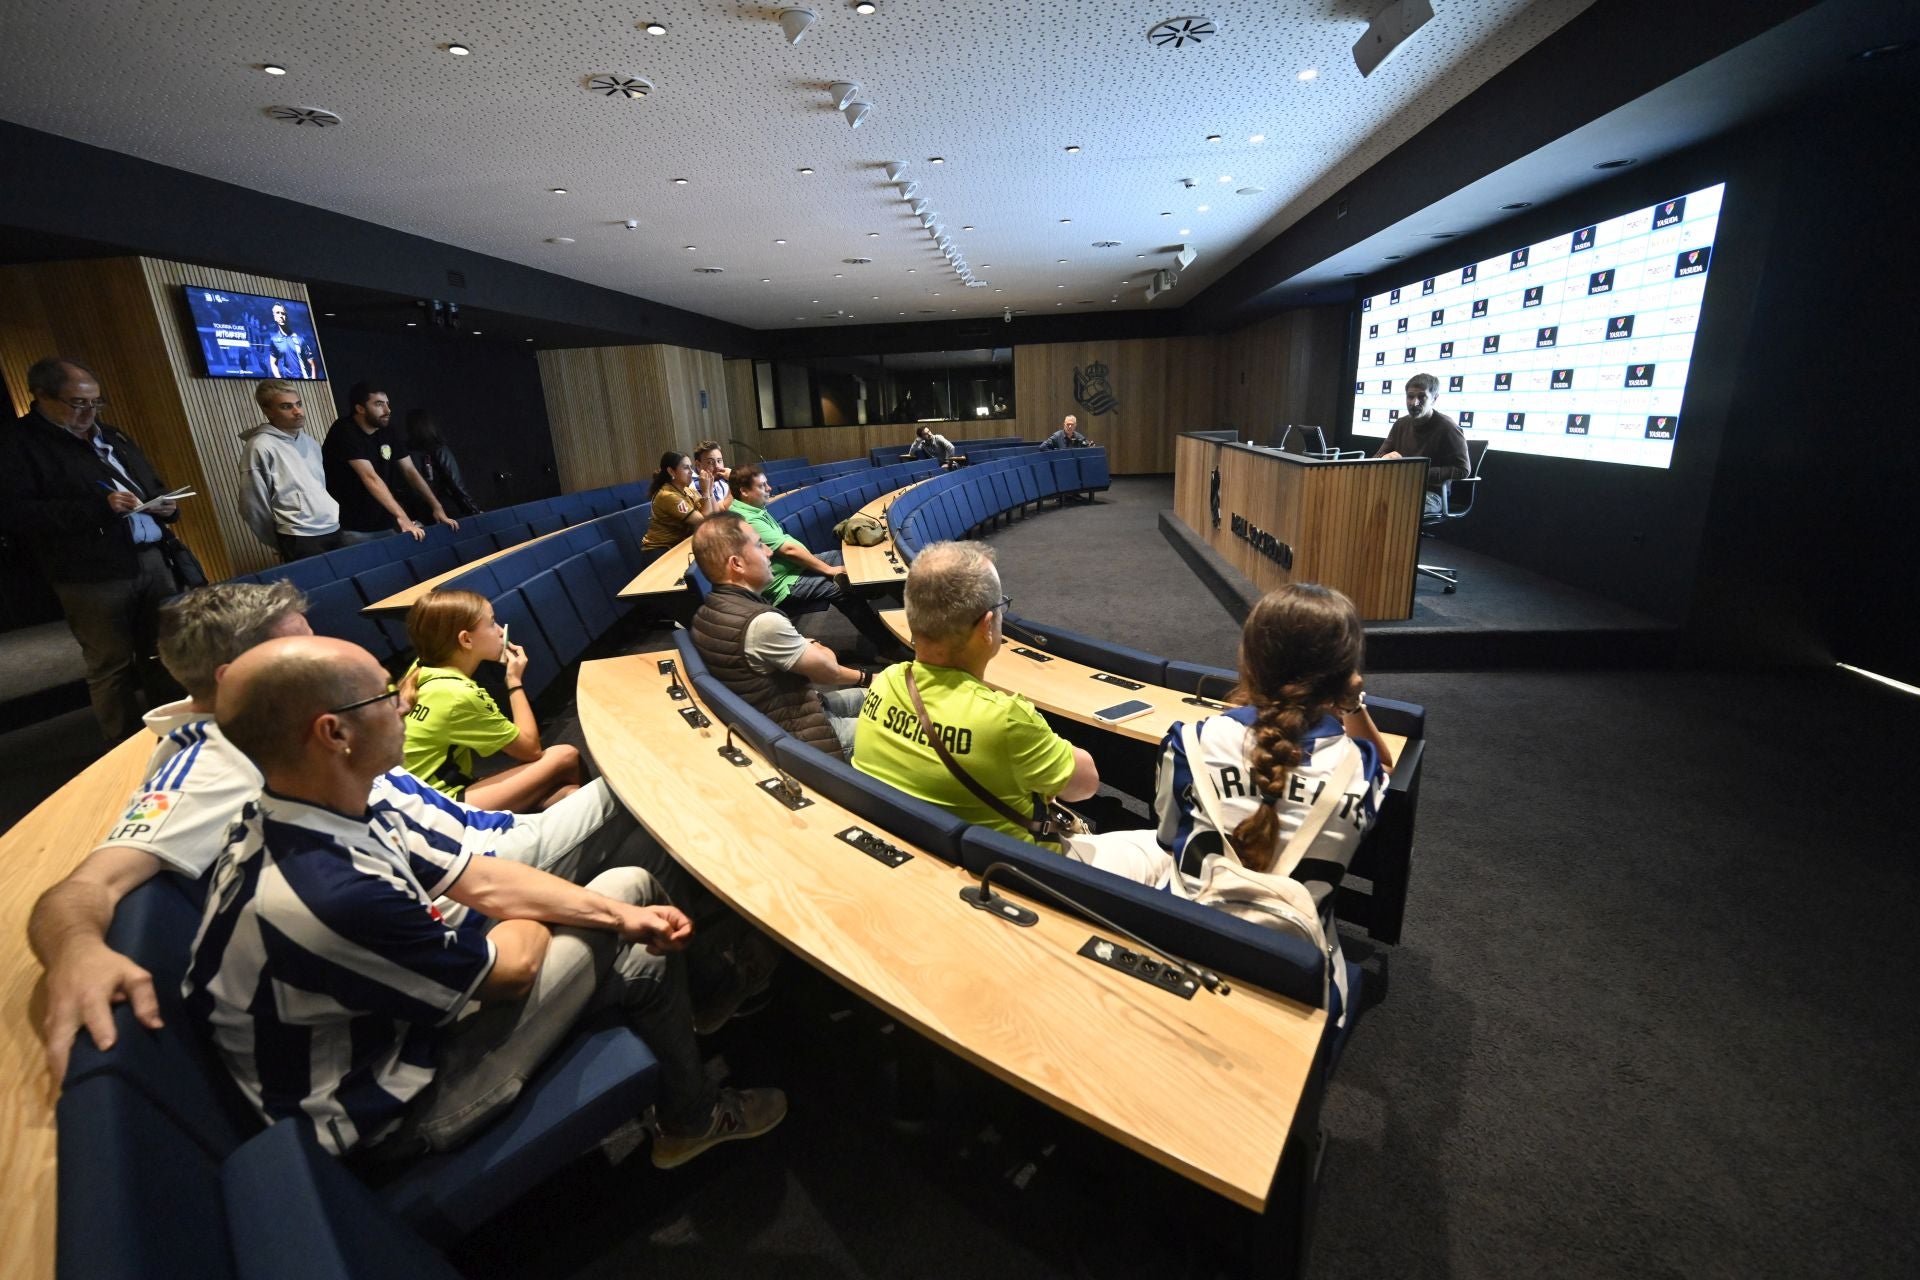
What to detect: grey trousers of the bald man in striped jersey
<box><xmin>378</xmin><ymin>867</ymin><xmax>718</xmax><ymax>1157</ymax></box>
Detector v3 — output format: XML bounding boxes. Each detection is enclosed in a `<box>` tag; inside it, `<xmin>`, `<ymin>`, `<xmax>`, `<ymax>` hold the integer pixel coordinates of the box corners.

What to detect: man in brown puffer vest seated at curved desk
<box><xmin>693</xmin><ymin>512</ymin><xmax>874</xmax><ymax>760</ymax></box>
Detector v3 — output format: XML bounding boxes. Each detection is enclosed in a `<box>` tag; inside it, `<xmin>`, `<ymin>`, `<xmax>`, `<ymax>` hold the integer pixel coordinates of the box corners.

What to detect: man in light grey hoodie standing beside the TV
<box><xmin>240</xmin><ymin>378</ymin><xmax>342</xmax><ymax>562</ymax></box>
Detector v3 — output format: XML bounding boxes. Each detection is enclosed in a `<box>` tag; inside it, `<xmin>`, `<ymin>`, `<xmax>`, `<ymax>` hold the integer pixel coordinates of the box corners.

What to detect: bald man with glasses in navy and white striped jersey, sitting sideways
<box><xmin>182</xmin><ymin>635</ymin><xmax>787</xmax><ymax>1169</ymax></box>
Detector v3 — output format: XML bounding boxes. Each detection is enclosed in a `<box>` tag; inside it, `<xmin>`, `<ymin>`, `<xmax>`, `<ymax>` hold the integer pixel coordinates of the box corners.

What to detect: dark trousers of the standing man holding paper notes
<box><xmin>54</xmin><ymin>543</ymin><xmax>179</xmax><ymax>743</ymax></box>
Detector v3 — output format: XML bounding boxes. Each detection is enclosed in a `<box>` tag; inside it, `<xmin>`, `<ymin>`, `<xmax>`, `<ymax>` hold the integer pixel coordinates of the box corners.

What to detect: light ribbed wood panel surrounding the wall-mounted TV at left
<box><xmin>138</xmin><ymin>257</ymin><xmax>334</xmax><ymax>578</ymax></box>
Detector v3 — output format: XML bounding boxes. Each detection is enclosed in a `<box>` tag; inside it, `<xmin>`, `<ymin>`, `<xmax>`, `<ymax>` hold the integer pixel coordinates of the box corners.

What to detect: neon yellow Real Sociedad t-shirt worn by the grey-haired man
<box><xmin>852</xmin><ymin>662</ymin><xmax>1073</xmax><ymax>841</ymax></box>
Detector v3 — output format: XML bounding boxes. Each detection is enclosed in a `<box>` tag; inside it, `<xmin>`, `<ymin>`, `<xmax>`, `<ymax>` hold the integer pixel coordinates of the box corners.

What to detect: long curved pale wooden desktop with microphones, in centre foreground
<box><xmin>578</xmin><ymin>652</ymin><xmax>1327</xmax><ymax>1211</ymax></box>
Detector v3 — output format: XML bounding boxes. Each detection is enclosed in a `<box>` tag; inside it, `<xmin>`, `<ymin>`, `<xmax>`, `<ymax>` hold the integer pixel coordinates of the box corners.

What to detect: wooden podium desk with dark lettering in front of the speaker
<box><xmin>1173</xmin><ymin>434</ymin><xmax>1427</xmax><ymax>622</ymax></box>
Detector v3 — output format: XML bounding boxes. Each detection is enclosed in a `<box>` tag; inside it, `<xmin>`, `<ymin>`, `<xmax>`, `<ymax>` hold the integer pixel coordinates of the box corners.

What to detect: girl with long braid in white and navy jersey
<box><xmin>1068</xmin><ymin>583</ymin><xmax>1392</xmax><ymax>971</ymax></box>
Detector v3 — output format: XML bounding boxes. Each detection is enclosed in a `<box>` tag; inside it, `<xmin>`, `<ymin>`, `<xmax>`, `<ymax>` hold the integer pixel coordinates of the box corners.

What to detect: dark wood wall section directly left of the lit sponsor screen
<box><xmin>1205</xmin><ymin>307</ymin><xmax>1346</xmax><ymax>443</ymax></box>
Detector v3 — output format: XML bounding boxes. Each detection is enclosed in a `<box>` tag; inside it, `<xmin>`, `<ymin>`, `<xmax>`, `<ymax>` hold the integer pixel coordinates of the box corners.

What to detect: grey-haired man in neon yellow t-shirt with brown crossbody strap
<box><xmin>852</xmin><ymin>543</ymin><xmax>1100</xmax><ymax>841</ymax></box>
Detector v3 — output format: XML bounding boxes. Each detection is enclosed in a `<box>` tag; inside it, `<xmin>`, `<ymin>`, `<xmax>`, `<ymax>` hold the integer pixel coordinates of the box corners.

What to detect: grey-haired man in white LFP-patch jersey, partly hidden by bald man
<box><xmin>27</xmin><ymin>581</ymin><xmax>652</xmax><ymax>1086</ymax></box>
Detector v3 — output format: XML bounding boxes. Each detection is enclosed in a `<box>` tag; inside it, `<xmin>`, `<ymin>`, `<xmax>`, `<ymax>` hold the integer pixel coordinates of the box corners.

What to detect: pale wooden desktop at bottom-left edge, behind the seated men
<box><xmin>0</xmin><ymin>729</ymin><xmax>154</xmax><ymax>1280</ymax></box>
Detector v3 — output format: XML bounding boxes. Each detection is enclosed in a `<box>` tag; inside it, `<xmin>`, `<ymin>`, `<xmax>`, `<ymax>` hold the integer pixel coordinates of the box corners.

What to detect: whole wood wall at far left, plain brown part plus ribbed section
<box><xmin>0</xmin><ymin>257</ymin><xmax>316</xmax><ymax>578</ymax></box>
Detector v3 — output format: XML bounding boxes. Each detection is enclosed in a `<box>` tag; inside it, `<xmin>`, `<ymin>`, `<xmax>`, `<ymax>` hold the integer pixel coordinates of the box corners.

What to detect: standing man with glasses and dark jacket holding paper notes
<box><xmin>0</xmin><ymin>355</ymin><xmax>180</xmax><ymax>743</ymax></box>
